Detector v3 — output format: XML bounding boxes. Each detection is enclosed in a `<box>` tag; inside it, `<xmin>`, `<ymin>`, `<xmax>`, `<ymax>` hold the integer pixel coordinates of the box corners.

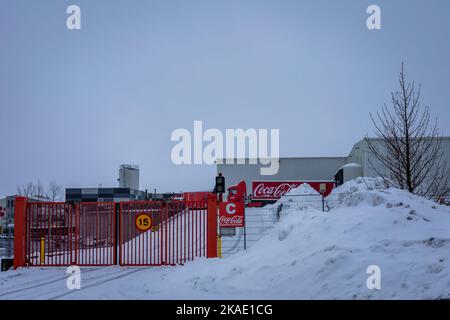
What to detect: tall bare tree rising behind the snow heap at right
<box><xmin>366</xmin><ymin>63</ymin><xmax>450</xmax><ymax>198</ymax></box>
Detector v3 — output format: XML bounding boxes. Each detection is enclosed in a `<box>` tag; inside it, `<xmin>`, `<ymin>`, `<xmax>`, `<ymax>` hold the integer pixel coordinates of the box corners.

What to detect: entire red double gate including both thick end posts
<box><xmin>14</xmin><ymin>197</ymin><xmax>217</xmax><ymax>268</ymax></box>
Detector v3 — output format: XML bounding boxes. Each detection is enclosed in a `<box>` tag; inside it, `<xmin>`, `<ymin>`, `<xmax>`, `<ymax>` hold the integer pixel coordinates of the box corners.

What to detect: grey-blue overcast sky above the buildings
<box><xmin>0</xmin><ymin>0</ymin><xmax>450</xmax><ymax>196</ymax></box>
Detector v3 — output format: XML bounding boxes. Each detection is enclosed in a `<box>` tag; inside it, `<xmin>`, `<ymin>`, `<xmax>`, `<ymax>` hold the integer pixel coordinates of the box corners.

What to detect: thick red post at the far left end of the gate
<box><xmin>14</xmin><ymin>197</ymin><xmax>27</xmax><ymax>270</ymax></box>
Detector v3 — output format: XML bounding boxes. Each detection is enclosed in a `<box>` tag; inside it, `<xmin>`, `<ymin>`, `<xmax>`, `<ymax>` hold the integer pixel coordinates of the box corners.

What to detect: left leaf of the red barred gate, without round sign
<box><xmin>25</xmin><ymin>202</ymin><xmax>115</xmax><ymax>266</ymax></box>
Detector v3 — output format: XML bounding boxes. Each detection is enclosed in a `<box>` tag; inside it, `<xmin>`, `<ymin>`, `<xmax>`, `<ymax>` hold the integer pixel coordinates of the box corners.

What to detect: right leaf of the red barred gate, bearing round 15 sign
<box><xmin>119</xmin><ymin>201</ymin><xmax>208</xmax><ymax>266</ymax></box>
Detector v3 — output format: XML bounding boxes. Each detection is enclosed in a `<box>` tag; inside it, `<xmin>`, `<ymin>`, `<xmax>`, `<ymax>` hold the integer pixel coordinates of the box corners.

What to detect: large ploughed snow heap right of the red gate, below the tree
<box><xmin>171</xmin><ymin>179</ymin><xmax>450</xmax><ymax>299</ymax></box>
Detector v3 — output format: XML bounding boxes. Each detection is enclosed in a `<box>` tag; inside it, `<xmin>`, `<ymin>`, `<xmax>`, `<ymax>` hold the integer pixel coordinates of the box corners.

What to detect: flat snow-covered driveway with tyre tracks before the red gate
<box><xmin>0</xmin><ymin>260</ymin><xmax>268</xmax><ymax>300</ymax></box>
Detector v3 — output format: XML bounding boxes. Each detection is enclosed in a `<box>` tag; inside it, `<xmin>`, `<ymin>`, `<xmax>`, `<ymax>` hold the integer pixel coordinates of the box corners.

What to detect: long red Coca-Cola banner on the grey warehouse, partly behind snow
<box><xmin>252</xmin><ymin>181</ymin><xmax>334</xmax><ymax>200</ymax></box>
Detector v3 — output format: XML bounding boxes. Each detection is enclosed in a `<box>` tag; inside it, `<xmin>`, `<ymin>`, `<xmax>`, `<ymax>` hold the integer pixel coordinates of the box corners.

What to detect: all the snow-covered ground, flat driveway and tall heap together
<box><xmin>0</xmin><ymin>178</ymin><xmax>450</xmax><ymax>299</ymax></box>
